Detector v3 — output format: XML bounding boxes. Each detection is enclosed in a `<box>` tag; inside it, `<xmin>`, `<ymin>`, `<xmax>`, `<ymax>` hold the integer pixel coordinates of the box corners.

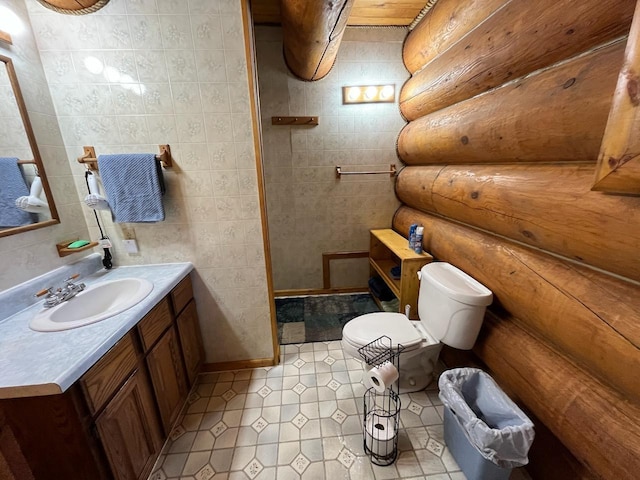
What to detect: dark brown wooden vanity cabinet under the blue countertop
<box><xmin>0</xmin><ymin>276</ymin><xmax>203</xmax><ymax>480</ymax></box>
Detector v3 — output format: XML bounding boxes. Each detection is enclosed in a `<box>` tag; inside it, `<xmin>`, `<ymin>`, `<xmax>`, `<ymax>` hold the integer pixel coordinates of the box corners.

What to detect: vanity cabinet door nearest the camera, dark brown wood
<box><xmin>96</xmin><ymin>369</ymin><xmax>162</xmax><ymax>480</ymax></box>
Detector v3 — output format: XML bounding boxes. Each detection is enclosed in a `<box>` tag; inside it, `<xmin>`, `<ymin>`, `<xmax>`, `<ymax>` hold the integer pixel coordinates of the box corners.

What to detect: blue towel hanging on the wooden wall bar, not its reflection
<box><xmin>98</xmin><ymin>153</ymin><xmax>164</xmax><ymax>223</ymax></box>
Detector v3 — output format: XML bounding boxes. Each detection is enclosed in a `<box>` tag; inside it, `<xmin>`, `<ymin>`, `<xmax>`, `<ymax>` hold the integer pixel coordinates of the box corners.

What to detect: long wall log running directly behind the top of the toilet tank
<box><xmin>393</xmin><ymin>206</ymin><xmax>640</xmax><ymax>401</ymax></box>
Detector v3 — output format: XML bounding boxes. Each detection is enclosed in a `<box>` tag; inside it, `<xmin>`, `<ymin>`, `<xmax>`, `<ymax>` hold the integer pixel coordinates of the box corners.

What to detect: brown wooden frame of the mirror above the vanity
<box><xmin>0</xmin><ymin>55</ymin><xmax>60</xmax><ymax>237</ymax></box>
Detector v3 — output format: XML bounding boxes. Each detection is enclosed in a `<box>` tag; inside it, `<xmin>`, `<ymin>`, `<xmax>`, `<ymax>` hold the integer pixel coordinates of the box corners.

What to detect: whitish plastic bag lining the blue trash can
<box><xmin>438</xmin><ymin>368</ymin><xmax>534</xmax><ymax>468</ymax></box>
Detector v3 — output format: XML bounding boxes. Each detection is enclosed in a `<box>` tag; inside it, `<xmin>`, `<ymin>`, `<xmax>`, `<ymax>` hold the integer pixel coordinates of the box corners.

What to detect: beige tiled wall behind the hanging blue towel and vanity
<box><xmin>27</xmin><ymin>0</ymin><xmax>273</xmax><ymax>362</ymax></box>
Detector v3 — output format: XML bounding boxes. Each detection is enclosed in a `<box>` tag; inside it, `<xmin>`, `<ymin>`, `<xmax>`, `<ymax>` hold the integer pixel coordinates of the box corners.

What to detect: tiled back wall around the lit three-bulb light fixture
<box><xmin>256</xmin><ymin>27</ymin><xmax>408</xmax><ymax>290</ymax></box>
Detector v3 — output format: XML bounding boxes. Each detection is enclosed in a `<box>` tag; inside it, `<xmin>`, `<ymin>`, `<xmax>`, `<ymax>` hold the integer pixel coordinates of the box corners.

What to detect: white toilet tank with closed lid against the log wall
<box><xmin>418</xmin><ymin>262</ymin><xmax>493</xmax><ymax>350</ymax></box>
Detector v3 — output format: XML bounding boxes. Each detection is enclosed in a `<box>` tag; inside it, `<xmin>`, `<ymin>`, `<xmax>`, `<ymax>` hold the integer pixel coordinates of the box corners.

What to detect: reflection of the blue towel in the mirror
<box><xmin>0</xmin><ymin>157</ymin><xmax>37</xmax><ymax>228</ymax></box>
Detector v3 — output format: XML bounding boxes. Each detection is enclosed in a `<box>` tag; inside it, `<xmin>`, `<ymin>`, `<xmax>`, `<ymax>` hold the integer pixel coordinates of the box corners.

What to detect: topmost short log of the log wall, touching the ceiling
<box><xmin>402</xmin><ymin>0</ymin><xmax>510</xmax><ymax>74</ymax></box>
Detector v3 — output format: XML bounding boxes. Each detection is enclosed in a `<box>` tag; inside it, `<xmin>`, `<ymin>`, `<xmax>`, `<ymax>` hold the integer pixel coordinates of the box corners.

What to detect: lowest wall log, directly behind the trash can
<box><xmin>474</xmin><ymin>314</ymin><xmax>640</xmax><ymax>479</ymax></box>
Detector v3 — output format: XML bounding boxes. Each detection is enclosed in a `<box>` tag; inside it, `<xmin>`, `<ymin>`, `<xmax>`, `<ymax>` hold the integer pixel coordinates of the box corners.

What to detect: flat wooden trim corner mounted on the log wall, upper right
<box><xmin>593</xmin><ymin>1</ymin><xmax>640</xmax><ymax>195</ymax></box>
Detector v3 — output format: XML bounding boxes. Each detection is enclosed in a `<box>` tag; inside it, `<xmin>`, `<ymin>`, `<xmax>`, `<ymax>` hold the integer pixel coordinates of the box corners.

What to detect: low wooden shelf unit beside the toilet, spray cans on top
<box><xmin>369</xmin><ymin>228</ymin><xmax>433</xmax><ymax>319</ymax></box>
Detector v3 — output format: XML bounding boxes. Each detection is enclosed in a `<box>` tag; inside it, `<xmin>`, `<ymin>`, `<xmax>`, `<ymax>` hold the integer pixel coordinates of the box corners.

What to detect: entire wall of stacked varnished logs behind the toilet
<box><xmin>393</xmin><ymin>0</ymin><xmax>640</xmax><ymax>479</ymax></box>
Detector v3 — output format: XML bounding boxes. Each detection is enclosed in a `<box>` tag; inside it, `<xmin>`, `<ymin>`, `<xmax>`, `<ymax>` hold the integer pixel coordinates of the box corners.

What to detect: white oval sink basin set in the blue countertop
<box><xmin>29</xmin><ymin>278</ymin><xmax>153</xmax><ymax>332</ymax></box>
